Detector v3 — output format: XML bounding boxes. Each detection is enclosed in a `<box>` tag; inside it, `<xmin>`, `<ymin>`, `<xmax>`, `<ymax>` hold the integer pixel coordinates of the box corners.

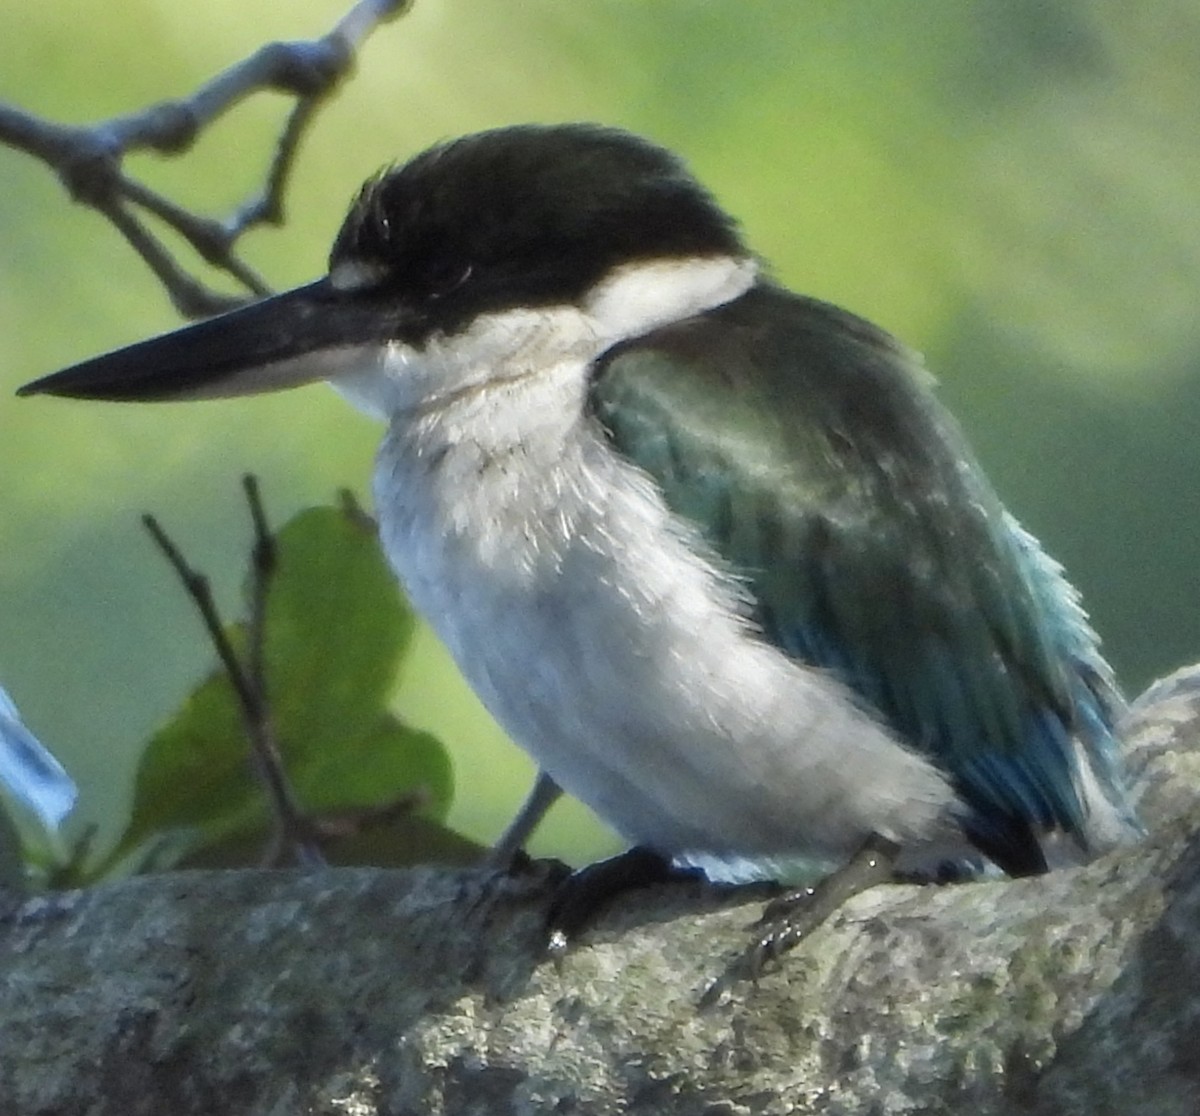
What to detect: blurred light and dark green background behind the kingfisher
<box><xmin>0</xmin><ymin>0</ymin><xmax>1200</xmax><ymax>860</ymax></box>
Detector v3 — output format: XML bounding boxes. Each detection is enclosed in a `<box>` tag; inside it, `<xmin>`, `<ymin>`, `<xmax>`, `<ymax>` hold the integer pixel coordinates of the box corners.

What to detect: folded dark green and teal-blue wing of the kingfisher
<box><xmin>589</xmin><ymin>286</ymin><xmax>1123</xmax><ymax>874</ymax></box>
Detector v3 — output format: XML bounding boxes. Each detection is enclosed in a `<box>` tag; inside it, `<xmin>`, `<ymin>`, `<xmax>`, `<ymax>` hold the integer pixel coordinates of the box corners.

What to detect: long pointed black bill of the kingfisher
<box><xmin>17</xmin><ymin>278</ymin><xmax>397</xmax><ymax>402</ymax></box>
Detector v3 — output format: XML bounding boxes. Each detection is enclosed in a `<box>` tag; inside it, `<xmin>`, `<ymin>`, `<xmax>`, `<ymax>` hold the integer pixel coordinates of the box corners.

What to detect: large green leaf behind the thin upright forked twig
<box><xmin>95</xmin><ymin>508</ymin><xmax>454</xmax><ymax>874</ymax></box>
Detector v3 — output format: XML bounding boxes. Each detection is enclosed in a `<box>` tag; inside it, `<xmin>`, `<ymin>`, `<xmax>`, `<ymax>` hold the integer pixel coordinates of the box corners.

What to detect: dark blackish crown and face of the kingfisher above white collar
<box><xmin>330</xmin><ymin>124</ymin><xmax>745</xmax><ymax>332</ymax></box>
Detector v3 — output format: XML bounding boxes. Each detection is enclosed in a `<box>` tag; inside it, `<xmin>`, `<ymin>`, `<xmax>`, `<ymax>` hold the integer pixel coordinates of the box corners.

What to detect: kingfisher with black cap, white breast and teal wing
<box><xmin>20</xmin><ymin>124</ymin><xmax>1138</xmax><ymax>926</ymax></box>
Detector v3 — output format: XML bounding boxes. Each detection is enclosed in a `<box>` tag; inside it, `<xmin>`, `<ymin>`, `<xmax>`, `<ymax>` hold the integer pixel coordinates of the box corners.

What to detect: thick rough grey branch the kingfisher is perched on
<box><xmin>0</xmin><ymin>667</ymin><xmax>1200</xmax><ymax>1116</ymax></box>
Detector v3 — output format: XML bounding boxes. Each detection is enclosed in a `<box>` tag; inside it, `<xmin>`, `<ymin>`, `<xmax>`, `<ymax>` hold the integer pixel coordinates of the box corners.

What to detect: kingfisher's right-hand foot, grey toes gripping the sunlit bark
<box><xmin>700</xmin><ymin>834</ymin><xmax>900</xmax><ymax>1009</ymax></box>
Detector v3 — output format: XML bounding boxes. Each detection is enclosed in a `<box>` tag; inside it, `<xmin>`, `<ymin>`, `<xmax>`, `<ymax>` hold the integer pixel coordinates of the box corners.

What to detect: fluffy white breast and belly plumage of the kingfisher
<box><xmin>376</xmin><ymin>366</ymin><xmax>956</xmax><ymax>870</ymax></box>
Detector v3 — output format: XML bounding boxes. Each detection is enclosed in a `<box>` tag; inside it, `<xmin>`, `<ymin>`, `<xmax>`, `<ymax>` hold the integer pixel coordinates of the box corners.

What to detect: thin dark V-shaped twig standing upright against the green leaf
<box><xmin>142</xmin><ymin>494</ymin><xmax>325</xmax><ymax>866</ymax></box>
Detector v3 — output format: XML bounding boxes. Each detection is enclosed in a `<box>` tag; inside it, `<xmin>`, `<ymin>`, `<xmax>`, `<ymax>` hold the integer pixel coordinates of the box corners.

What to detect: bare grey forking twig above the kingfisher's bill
<box><xmin>0</xmin><ymin>0</ymin><xmax>409</xmax><ymax>318</ymax></box>
